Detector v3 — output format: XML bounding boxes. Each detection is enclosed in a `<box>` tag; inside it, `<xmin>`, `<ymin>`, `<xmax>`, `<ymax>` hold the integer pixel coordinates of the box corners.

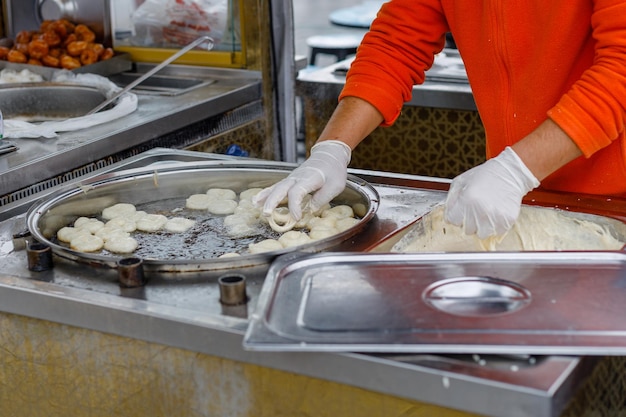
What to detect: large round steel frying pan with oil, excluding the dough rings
<box><xmin>27</xmin><ymin>161</ymin><xmax>379</xmax><ymax>272</ymax></box>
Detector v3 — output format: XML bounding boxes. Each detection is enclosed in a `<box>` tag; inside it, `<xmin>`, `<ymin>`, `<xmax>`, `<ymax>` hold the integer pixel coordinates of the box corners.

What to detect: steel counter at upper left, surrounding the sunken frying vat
<box><xmin>0</xmin><ymin>64</ymin><xmax>261</xmax><ymax>213</ymax></box>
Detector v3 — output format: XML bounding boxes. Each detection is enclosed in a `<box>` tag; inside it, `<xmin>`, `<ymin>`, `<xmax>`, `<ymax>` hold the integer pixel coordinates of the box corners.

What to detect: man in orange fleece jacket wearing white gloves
<box><xmin>257</xmin><ymin>0</ymin><xmax>626</xmax><ymax>238</ymax></box>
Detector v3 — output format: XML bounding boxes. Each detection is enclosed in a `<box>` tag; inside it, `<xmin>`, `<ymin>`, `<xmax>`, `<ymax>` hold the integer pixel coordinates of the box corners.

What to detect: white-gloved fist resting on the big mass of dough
<box><xmin>444</xmin><ymin>147</ymin><xmax>539</xmax><ymax>239</ymax></box>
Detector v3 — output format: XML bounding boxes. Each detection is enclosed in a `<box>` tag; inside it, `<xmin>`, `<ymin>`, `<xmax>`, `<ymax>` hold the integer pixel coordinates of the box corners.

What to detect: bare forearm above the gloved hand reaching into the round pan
<box><xmin>318</xmin><ymin>97</ymin><xmax>383</xmax><ymax>149</ymax></box>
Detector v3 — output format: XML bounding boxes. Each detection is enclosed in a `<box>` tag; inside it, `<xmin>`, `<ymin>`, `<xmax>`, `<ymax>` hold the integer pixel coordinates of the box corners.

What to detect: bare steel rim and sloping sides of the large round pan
<box><xmin>27</xmin><ymin>161</ymin><xmax>379</xmax><ymax>272</ymax></box>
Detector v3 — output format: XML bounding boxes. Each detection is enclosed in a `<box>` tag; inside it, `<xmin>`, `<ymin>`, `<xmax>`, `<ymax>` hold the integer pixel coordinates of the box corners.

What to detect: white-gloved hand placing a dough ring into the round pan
<box><xmin>253</xmin><ymin>140</ymin><xmax>352</xmax><ymax>220</ymax></box>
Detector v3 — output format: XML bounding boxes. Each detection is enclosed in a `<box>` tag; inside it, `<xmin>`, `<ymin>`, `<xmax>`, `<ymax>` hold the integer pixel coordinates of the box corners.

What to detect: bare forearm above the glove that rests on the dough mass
<box><xmin>512</xmin><ymin>119</ymin><xmax>582</xmax><ymax>181</ymax></box>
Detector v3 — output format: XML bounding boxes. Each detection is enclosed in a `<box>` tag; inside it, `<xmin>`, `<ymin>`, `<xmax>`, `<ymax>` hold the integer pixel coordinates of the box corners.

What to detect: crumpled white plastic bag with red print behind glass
<box><xmin>131</xmin><ymin>0</ymin><xmax>228</xmax><ymax>48</ymax></box>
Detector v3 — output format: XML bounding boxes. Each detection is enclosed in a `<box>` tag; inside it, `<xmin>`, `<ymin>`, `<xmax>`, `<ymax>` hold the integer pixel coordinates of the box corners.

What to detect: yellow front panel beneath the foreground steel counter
<box><xmin>0</xmin><ymin>313</ymin><xmax>480</xmax><ymax>417</ymax></box>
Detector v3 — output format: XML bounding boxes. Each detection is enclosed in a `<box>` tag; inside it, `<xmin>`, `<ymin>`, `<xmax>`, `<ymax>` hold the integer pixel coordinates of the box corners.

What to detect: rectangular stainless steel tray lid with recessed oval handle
<box><xmin>244</xmin><ymin>251</ymin><xmax>626</xmax><ymax>355</ymax></box>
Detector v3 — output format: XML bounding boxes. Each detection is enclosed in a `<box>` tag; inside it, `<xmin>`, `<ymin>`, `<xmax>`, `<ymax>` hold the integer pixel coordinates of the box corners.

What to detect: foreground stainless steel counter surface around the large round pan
<box><xmin>0</xmin><ymin>149</ymin><xmax>595</xmax><ymax>417</ymax></box>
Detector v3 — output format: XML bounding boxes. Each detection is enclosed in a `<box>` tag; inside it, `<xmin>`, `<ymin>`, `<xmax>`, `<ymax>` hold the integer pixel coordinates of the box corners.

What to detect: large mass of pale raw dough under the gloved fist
<box><xmin>391</xmin><ymin>206</ymin><xmax>624</xmax><ymax>252</ymax></box>
